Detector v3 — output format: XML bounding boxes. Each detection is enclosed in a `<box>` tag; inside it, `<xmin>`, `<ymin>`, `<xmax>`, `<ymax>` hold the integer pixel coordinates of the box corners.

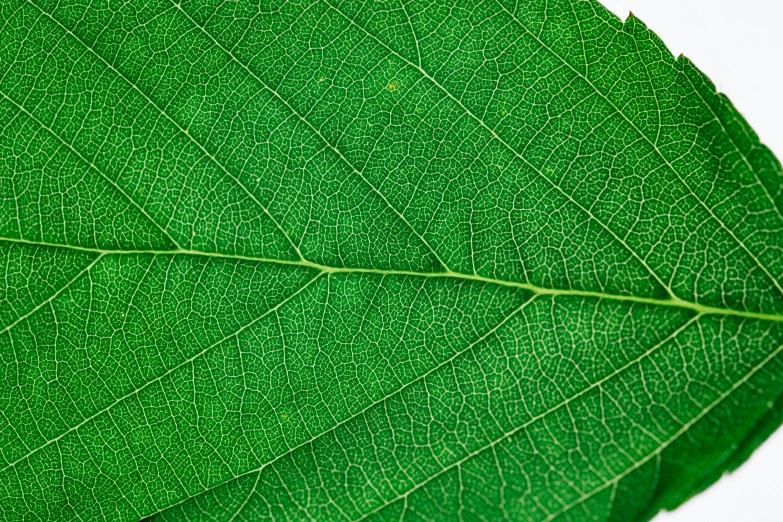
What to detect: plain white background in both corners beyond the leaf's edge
<box><xmin>600</xmin><ymin>0</ymin><xmax>783</xmax><ymax>522</ymax></box>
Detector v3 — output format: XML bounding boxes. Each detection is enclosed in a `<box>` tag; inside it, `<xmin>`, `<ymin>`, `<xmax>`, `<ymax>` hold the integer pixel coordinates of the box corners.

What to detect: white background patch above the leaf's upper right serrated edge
<box><xmin>599</xmin><ymin>0</ymin><xmax>783</xmax><ymax>158</ymax></box>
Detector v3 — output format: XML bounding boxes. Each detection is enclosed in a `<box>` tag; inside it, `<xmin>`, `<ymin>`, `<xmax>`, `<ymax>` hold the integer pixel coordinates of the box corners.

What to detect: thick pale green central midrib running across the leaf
<box><xmin>0</xmin><ymin>238</ymin><xmax>783</xmax><ymax>322</ymax></box>
